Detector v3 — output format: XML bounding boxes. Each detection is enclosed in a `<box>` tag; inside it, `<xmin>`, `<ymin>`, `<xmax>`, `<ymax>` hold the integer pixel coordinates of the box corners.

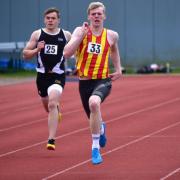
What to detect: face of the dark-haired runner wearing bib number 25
<box><xmin>44</xmin><ymin>12</ymin><xmax>59</xmax><ymax>30</ymax></box>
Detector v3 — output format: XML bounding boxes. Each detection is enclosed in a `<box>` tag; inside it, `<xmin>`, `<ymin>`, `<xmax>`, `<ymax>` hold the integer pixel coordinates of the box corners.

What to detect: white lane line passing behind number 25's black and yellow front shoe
<box><xmin>0</xmin><ymin>98</ymin><xmax>180</xmax><ymax>158</ymax></box>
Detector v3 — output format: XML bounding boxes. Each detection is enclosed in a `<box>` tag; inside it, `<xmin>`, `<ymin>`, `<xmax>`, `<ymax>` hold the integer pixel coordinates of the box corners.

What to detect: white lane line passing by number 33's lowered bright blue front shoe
<box><xmin>42</xmin><ymin>122</ymin><xmax>180</xmax><ymax>180</ymax></box>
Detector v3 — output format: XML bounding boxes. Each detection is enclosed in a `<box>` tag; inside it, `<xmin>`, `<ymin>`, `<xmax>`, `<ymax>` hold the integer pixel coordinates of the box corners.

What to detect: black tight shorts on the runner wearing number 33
<box><xmin>79</xmin><ymin>78</ymin><xmax>112</xmax><ymax>118</ymax></box>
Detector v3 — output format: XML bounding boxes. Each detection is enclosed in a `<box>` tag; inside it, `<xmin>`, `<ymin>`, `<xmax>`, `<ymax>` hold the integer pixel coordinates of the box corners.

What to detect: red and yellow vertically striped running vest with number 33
<box><xmin>76</xmin><ymin>28</ymin><xmax>110</xmax><ymax>79</ymax></box>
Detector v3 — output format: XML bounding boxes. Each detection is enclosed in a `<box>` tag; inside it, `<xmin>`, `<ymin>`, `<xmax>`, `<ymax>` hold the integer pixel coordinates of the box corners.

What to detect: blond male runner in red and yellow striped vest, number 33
<box><xmin>64</xmin><ymin>2</ymin><xmax>122</xmax><ymax>164</ymax></box>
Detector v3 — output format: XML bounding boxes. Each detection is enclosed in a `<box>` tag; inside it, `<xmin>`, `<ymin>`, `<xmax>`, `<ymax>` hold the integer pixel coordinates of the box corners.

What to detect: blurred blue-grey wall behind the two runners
<box><xmin>0</xmin><ymin>0</ymin><xmax>180</xmax><ymax>73</ymax></box>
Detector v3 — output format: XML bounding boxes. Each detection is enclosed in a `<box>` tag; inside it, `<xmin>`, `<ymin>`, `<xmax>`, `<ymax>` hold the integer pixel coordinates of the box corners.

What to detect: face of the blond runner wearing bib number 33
<box><xmin>88</xmin><ymin>7</ymin><xmax>105</xmax><ymax>27</ymax></box>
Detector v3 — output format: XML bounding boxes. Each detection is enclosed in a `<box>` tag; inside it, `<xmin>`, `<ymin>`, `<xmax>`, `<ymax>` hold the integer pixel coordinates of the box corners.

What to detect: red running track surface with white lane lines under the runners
<box><xmin>0</xmin><ymin>75</ymin><xmax>180</xmax><ymax>180</ymax></box>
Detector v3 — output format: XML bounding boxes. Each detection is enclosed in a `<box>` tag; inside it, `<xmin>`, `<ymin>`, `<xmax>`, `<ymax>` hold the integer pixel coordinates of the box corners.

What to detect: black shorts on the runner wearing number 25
<box><xmin>36</xmin><ymin>72</ymin><xmax>66</xmax><ymax>97</ymax></box>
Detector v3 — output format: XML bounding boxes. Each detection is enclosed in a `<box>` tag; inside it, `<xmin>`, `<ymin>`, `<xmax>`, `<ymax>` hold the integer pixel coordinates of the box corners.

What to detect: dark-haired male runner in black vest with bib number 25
<box><xmin>23</xmin><ymin>8</ymin><xmax>71</xmax><ymax>150</ymax></box>
